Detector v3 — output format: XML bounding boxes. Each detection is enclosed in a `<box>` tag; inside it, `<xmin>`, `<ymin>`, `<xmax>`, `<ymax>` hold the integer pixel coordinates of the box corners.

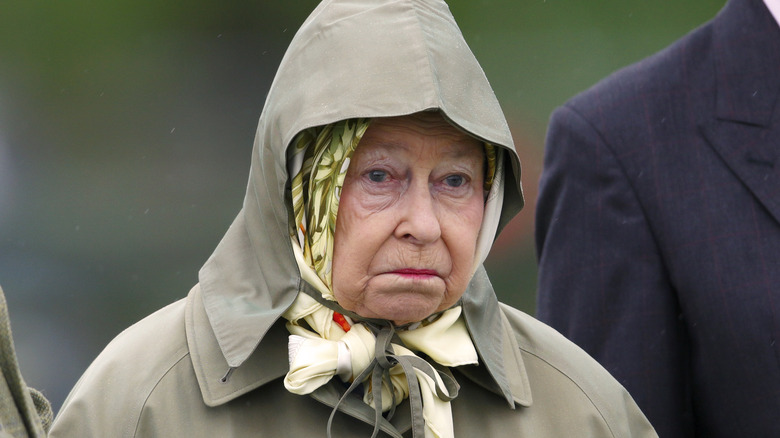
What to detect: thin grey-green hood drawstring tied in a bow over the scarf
<box><xmin>327</xmin><ymin>324</ymin><xmax>460</xmax><ymax>438</ymax></box>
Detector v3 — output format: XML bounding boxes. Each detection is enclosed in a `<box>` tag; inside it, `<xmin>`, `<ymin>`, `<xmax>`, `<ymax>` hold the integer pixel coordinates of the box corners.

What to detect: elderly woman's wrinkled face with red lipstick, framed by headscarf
<box><xmin>332</xmin><ymin>113</ymin><xmax>484</xmax><ymax>325</ymax></box>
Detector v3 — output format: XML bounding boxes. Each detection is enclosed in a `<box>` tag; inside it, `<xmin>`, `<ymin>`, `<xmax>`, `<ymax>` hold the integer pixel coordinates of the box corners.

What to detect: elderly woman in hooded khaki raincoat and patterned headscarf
<box><xmin>51</xmin><ymin>0</ymin><xmax>655</xmax><ymax>438</ymax></box>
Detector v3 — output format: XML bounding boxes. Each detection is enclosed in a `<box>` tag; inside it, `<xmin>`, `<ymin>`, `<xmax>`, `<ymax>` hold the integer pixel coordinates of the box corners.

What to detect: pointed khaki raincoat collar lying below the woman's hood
<box><xmin>185</xmin><ymin>278</ymin><xmax>532</xmax><ymax>410</ymax></box>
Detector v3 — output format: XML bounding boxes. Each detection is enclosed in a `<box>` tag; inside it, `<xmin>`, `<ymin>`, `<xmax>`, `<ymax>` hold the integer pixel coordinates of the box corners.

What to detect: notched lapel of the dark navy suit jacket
<box><xmin>702</xmin><ymin>0</ymin><xmax>780</xmax><ymax>222</ymax></box>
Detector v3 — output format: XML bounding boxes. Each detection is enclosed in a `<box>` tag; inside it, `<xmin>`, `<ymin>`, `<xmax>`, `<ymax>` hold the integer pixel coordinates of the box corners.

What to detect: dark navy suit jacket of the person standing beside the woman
<box><xmin>536</xmin><ymin>0</ymin><xmax>780</xmax><ymax>438</ymax></box>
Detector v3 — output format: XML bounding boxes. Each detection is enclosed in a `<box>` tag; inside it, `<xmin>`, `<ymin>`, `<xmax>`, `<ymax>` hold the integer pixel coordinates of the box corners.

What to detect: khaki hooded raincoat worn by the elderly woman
<box><xmin>51</xmin><ymin>0</ymin><xmax>655</xmax><ymax>437</ymax></box>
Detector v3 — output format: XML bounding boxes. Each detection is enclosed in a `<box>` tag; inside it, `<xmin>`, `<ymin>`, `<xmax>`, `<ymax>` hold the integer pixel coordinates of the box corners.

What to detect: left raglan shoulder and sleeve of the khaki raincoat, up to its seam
<box><xmin>49</xmin><ymin>300</ymin><xmax>192</xmax><ymax>437</ymax></box>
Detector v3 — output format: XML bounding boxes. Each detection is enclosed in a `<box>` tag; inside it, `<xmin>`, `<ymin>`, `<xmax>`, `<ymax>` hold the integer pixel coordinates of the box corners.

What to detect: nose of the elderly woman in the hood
<box><xmin>395</xmin><ymin>181</ymin><xmax>441</xmax><ymax>245</ymax></box>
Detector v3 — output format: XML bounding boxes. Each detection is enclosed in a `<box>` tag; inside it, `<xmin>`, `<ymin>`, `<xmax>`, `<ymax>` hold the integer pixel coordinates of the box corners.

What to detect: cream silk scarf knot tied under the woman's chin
<box><xmin>284</xmin><ymin>293</ymin><xmax>477</xmax><ymax>438</ymax></box>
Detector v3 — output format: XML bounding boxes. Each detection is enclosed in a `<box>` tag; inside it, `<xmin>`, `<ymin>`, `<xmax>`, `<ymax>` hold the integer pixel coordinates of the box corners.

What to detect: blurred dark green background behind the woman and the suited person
<box><xmin>0</xmin><ymin>0</ymin><xmax>723</xmax><ymax>409</ymax></box>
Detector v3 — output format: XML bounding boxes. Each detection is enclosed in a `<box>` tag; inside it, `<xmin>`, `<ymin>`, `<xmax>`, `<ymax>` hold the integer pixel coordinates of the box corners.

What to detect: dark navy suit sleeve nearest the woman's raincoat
<box><xmin>536</xmin><ymin>107</ymin><xmax>692</xmax><ymax>437</ymax></box>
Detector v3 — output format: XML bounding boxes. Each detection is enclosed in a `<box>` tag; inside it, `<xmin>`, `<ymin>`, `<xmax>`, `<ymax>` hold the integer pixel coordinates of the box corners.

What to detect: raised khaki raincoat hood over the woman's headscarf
<box><xmin>199</xmin><ymin>0</ymin><xmax>523</xmax><ymax>376</ymax></box>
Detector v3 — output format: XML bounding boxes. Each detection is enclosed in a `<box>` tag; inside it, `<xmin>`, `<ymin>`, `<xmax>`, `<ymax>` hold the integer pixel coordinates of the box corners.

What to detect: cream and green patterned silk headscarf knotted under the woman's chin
<box><xmin>283</xmin><ymin>119</ymin><xmax>500</xmax><ymax>438</ymax></box>
